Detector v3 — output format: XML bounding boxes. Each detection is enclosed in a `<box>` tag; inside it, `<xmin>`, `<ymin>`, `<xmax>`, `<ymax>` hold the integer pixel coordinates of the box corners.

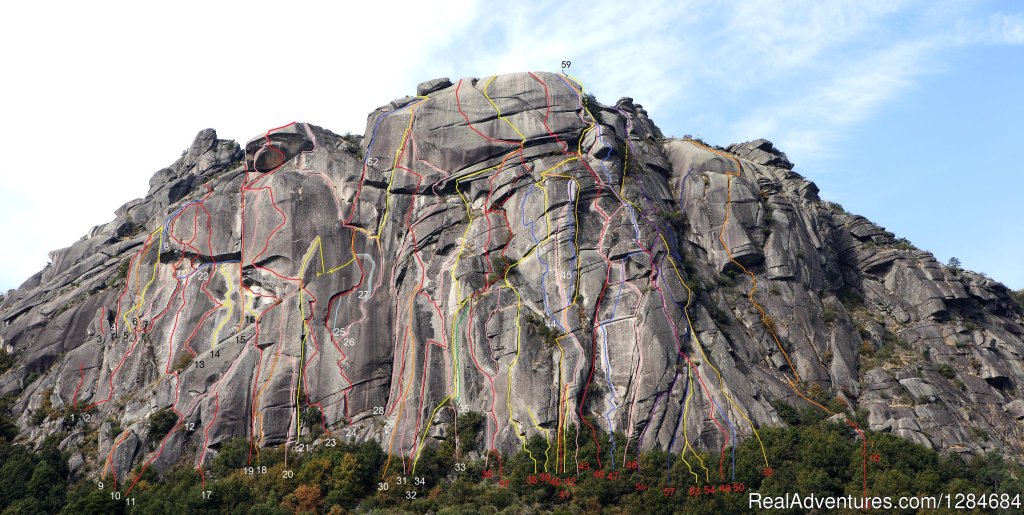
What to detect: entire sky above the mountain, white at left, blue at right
<box><xmin>0</xmin><ymin>0</ymin><xmax>1024</xmax><ymax>291</ymax></box>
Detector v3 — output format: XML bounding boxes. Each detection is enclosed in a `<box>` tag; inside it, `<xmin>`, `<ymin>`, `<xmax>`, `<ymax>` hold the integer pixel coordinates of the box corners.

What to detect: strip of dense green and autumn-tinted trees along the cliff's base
<box><xmin>0</xmin><ymin>393</ymin><xmax>1024</xmax><ymax>515</ymax></box>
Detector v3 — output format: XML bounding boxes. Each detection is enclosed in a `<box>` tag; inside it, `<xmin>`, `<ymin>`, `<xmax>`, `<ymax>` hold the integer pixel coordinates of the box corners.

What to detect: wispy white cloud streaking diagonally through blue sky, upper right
<box><xmin>729</xmin><ymin>2</ymin><xmax>1024</xmax><ymax>163</ymax></box>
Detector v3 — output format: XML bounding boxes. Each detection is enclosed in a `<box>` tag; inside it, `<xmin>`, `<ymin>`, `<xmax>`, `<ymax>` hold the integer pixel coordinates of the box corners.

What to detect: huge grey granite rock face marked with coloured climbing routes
<box><xmin>0</xmin><ymin>73</ymin><xmax>1024</xmax><ymax>477</ymax></box>
